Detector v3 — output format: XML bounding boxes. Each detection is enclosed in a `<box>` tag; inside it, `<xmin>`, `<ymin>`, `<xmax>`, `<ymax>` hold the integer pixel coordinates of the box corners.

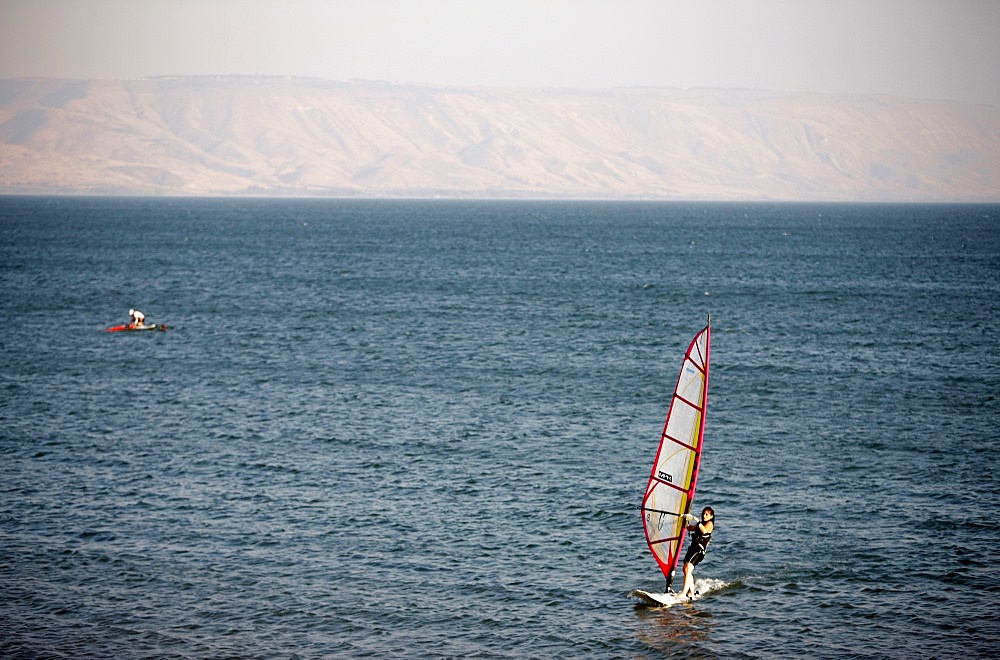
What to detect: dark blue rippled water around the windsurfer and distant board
<box><xmin>0</xmin><ymin>198</ymin><xmax>1000</xmax><ymax>658</ymax></box>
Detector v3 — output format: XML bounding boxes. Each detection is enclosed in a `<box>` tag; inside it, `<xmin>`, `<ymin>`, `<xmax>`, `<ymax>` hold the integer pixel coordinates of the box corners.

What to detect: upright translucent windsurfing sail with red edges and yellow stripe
<box><xmin>640</xmin><ymin>316</ymin><xmax>712</xmax><ymax>600</ymax></box>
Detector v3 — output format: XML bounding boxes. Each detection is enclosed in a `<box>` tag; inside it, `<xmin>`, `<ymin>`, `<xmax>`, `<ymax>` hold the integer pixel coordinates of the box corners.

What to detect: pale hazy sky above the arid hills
<box><xmin>0</xmin><ymin>0</ymin><xmax>1000</xmax><ymax>105</ymax></box>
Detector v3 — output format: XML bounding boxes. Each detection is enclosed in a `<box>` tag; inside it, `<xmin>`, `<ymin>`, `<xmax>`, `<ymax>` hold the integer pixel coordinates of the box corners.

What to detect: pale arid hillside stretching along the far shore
<box><xmin>0</xmin><ymin>77</ymin><xmax>1000</xmax><ymax>201</ymax></box>
